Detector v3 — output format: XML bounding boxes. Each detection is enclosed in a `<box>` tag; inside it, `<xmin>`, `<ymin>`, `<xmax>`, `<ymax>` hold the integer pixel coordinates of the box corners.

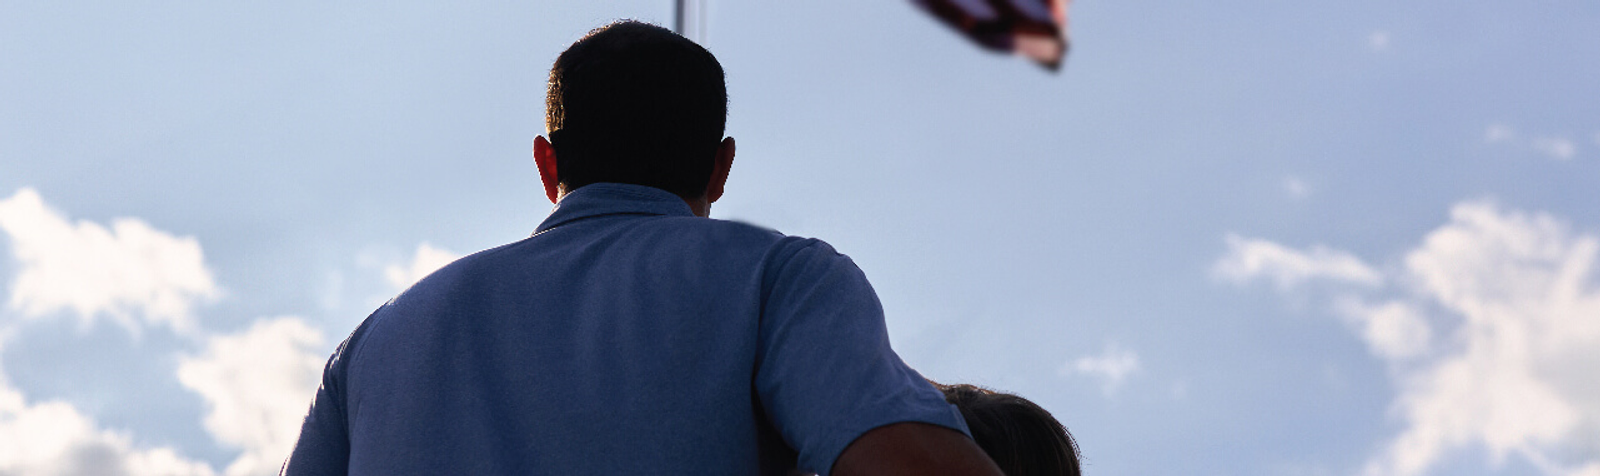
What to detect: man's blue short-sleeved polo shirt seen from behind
<box><xmin>285</xmin><ymin>184</ymin><xmax>966</xmax><ymax>474</ymax></box>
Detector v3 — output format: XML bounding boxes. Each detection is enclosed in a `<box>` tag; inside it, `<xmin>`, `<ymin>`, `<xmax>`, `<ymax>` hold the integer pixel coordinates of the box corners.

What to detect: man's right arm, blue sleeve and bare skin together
<box><xmin>755</xmin><ymin>240</ymin><xmax>1002</xmax><ymax>474</ymax></box>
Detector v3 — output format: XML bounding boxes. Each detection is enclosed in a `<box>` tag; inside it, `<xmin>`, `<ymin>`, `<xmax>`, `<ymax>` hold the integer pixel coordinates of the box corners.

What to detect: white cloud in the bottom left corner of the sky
<box><xmin>0</xmin><ymin>376</ymin><xmax>213</xmax><ymax>476</ymax></box>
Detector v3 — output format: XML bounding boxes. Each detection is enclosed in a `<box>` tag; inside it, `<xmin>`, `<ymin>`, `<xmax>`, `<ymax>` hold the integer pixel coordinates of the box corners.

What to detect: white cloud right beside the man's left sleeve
<box><xmin>178</xmin><ymin>318</ymin><xmax>323</xmax><ymax>476</ymax></box>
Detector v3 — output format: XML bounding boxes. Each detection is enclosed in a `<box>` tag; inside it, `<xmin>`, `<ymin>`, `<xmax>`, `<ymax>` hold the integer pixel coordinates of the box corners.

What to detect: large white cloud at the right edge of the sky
<box><xmin>1224</xmin><ymin>201</ymin><xmax>1600</xmax><ymax>476</ymax></box>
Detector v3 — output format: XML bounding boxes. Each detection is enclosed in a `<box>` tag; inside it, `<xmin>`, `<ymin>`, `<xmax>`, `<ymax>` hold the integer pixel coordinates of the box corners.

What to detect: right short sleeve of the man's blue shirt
<box><xmin>755</xmin><ymin>240</ymin><xmax>970</xmax><ymax>476</ymax></box>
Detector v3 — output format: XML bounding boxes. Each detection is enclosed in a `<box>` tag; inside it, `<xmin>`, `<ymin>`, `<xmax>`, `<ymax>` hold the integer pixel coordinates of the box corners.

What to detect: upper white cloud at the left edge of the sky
<box><xmin>0</xmin><ymin>188</ymin><xmax>219</xmax><ymax>332</ymax></box>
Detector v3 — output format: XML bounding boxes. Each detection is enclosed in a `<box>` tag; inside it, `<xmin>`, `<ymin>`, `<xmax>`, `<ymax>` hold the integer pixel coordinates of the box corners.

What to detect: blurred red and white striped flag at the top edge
<box><xmin>912</xmin><ymin>0</ymin><xmax>1070</xmax><ymax>70</ymax></box>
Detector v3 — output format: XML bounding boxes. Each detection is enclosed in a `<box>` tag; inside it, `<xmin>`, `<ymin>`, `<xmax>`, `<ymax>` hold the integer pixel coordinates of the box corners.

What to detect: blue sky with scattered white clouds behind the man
<box><xmin>0</xmin><ymin>0</ymin><xmax>1600</xmax><ymax>476</ymax></box>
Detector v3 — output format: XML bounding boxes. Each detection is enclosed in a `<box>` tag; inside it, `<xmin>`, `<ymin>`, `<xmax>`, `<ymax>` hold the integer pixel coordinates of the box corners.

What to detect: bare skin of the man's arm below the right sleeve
<box><xmin>830</xmin><ymin>423</ymin><xmax>1005</xmax><ymax>476</ymax></box>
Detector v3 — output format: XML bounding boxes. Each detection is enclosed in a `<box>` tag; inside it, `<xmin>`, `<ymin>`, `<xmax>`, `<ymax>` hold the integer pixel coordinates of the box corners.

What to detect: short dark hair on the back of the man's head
<box><xmin>544</xmin><ymin>21</ymin><xmax>728</xmax><ymax>198</ymax></box>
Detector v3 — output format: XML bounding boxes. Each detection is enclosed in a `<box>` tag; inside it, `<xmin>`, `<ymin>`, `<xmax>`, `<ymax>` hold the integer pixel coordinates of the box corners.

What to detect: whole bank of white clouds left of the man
<box><xmin>0</xmin><ymin>188</ymin><xmax>332</xmax><ymax>476</ymax></box>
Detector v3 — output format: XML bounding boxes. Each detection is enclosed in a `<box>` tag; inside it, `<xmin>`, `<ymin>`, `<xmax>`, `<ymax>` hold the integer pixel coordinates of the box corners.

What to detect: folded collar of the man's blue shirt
<box><xmin>534</xmin><ymin>184</ymin><xmax>694</xmax><ymax>233</ymax></box>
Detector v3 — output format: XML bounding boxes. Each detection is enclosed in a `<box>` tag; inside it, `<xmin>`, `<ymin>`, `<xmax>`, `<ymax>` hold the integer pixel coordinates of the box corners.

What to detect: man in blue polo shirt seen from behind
<box><xmin>285</xmin><ymin>22</ymin><xmax>998</xmax><ymax>474</ymax></box>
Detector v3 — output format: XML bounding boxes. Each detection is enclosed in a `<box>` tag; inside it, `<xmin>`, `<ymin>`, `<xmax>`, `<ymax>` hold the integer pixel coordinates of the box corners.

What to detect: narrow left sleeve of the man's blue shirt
<box><xmin>278</xmin><ymin>337</ymin><xmax>354</xmax><ymax>476</ymax></box>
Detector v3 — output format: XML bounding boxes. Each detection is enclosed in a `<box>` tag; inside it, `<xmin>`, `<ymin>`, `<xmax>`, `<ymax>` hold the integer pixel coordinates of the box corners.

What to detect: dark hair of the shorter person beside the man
<box><xmin>934</xmin><ymin>383</ymin><xmax>1083</xmax><ymax>476</ymax></box>
